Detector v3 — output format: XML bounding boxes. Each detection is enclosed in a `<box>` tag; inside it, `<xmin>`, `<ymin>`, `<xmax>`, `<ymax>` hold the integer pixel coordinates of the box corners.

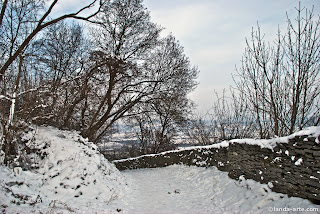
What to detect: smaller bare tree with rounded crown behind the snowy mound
<box><xmin>31</xmin><ymin>22</ymin><xmax>89</xmax><ymax>128</ymax></box>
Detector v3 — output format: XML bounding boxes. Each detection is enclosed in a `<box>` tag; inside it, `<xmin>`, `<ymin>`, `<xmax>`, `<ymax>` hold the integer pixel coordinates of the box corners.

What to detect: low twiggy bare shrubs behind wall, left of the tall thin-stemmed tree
<box><xmin>187</xmin><ymin>89</ymin><xmax>256</xmax><ymax>145</ymax></box>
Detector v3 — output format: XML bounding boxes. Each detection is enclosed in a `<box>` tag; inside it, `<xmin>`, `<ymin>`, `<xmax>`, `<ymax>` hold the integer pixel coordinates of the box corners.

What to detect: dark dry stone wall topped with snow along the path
<box><xmin>114</xmin><ymin>132</ymin><xmax>320</xmax><ymax>203</ymax></box>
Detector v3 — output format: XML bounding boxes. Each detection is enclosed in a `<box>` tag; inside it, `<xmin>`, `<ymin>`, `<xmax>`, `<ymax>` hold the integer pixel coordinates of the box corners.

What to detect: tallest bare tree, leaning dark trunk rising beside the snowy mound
<box><xmin>77</xmin><ymin>0</ymin><xmax>161</xmax><ymax>141</ymax></box>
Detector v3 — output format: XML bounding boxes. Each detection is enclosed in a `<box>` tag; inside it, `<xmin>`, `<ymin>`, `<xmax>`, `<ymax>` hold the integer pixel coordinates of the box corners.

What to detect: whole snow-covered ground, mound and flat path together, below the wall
<box><xmin>0</xmin><ymin>127</ymin><xmax>320</xmax><ymax>214</ymax></box>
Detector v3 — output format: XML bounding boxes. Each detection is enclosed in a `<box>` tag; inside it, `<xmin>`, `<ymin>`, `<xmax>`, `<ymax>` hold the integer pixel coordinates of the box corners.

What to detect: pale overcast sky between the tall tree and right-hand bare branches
<box><xmin>144</xmin><ymin>0</ymin><xmax>320</xmax><ymax>113</ymax></box>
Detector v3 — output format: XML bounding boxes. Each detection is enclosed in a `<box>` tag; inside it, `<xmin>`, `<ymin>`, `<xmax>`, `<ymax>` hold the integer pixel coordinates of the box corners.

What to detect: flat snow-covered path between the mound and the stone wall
<box><xmin>122</xmin><ymin>165</ymin><xmax>320</xmax><ymax>214</ymax></box>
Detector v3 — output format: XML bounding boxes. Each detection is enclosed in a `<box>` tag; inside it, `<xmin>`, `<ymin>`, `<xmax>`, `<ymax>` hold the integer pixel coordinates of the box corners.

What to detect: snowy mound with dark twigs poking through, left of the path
<box><xmin>0</xmin><ymin>127</ymin><xmax>126</xmax><ymax>213</ymax></box>
